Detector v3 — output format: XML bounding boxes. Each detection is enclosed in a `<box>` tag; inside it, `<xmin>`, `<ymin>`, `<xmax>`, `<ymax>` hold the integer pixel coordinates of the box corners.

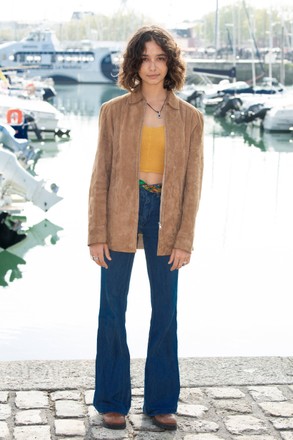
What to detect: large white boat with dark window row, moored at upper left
<box><xmin>0</xmin><ymin>30</ymin><xmax>121</xmax><ymax>84</ymax></box>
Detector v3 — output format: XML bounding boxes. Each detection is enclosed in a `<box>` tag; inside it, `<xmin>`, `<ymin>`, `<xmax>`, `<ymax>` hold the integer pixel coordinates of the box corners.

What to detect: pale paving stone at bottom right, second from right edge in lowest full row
<box><xmin>224</xmin><ymin>415</ymin><xmax>267</xmax><ymax>435</ymax></box>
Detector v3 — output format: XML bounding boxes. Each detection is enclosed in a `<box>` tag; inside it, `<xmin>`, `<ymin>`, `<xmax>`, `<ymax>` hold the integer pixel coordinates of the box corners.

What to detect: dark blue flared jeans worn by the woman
<box><xmin>94</xmin><ymin>188</ymin><xmax>180</xmax><ymax>416</ymax></box>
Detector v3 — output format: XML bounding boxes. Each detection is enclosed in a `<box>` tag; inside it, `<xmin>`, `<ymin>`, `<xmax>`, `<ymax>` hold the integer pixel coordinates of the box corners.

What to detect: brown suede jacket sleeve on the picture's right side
<box><xmin>174</xmin><ymin>111</ymin><xmax>204</xmax><ymax>252</ymax></box>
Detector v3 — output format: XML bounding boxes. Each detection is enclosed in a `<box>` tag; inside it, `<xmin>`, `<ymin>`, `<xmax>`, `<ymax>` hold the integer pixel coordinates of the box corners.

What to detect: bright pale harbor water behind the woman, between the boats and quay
<box><xmin>0</xmin><ymin>85</ymin><xmax>293</xmax><ymax>360</ymax></box>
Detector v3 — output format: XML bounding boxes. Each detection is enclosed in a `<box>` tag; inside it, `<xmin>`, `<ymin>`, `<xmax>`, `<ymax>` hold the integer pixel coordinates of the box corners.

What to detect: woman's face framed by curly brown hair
<box><xmin>138</xmin><ymin>41</ymin><xmax>168</xmax><ymax>86</ymax></box>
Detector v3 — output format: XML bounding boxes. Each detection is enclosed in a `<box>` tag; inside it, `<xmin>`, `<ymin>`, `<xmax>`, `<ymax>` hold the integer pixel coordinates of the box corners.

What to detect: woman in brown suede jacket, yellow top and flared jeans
<box><xmin>88</xmin><ymin>26</ymin><xmax>203</xmax><ymax>430</ymax></box>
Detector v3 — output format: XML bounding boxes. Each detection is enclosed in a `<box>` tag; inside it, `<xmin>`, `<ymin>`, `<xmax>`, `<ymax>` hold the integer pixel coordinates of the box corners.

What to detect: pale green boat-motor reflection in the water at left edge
<box><xmin>0</xmin><ymin>219</ymin><xmax>63</xmax><ymax>287</ymax></box>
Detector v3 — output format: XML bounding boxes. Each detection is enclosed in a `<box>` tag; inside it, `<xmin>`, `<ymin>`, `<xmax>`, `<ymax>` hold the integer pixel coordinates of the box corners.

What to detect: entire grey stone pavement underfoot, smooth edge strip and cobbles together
<box><xmin>0</xmin><ymin>357</ymin><xmax>293</xmax><ymax>440</ymax></box>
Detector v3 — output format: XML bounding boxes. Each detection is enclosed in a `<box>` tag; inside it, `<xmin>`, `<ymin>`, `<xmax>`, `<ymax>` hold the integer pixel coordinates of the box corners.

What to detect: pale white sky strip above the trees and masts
<box><xmin>0</xmin><ymin>0</ymin><xmax>293</xmax><ymax>24</ymax></box>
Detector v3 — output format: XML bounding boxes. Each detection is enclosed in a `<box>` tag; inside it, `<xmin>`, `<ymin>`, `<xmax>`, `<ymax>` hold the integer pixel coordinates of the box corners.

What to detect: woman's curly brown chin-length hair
<box><xmin>117</xmin><ymin>26</ymin><xmax>186</xmax><ymax>91</ymax></box>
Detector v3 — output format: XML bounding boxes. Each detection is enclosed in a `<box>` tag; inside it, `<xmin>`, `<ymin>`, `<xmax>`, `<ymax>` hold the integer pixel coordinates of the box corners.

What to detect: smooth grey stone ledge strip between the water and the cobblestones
<box><xmin>0</xmin><ymin>357</ymin><xmax>293</xmax><ymax>390</ymax></box>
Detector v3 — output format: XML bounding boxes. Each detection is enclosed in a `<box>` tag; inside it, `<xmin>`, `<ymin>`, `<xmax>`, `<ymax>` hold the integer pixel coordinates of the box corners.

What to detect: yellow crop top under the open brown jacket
<box><xmin>139</xmin><ymin>125</ymin><xmax>165</xmax><ymax>174</ymax></box>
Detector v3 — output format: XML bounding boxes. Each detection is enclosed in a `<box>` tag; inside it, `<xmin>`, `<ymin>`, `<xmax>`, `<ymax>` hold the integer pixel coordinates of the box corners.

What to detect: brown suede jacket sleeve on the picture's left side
<box><xmin>88</xmin><ymin>103</ymin><xmax>113</xmax><ymax>245</ymax></box>
